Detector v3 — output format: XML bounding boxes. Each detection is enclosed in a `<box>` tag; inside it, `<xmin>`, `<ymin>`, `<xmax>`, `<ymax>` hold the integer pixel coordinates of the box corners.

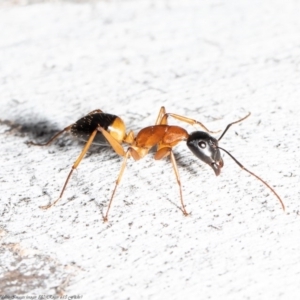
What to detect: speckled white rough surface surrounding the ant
<box><xmin>0</xmin><ymin>0</ymin><xmax>300</xmax><ymax>299</ymax></box>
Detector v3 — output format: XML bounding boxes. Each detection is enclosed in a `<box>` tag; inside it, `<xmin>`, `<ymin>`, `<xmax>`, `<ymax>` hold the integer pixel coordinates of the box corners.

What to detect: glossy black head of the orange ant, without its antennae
<box><xmin>187</xmin><ymin>131</ymin><xmax>224</xmax><ymax>176</ymax></box>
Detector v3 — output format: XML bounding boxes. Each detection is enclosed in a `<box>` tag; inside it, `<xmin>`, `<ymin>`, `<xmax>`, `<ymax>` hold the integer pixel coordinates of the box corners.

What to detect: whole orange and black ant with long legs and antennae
<box><xmin>30</xmin><ymin>107</ymin><xmax>285</xmax><ymax>221</ymax></box>
